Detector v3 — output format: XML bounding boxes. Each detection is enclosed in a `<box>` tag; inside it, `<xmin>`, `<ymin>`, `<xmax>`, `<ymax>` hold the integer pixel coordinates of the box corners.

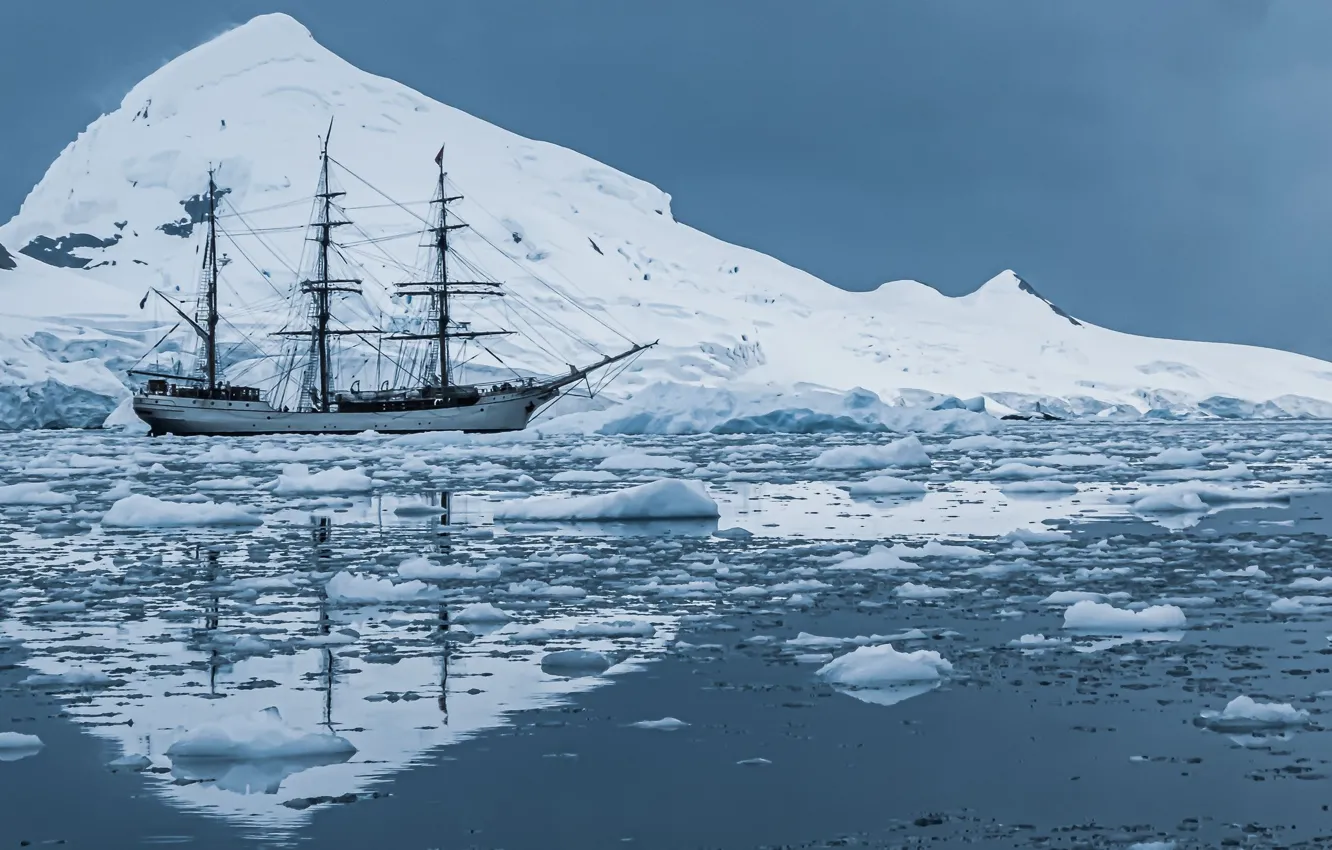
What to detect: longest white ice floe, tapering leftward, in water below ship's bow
<box><xmin>496</xmin><ymin>478</ymin><xmax>721</xmax><ymax>522</ymax></box>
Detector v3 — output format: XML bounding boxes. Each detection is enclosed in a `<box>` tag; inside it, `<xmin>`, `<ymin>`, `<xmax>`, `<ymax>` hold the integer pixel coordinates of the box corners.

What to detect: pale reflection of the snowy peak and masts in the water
<box><xmin>0</xmin><ymin>506</ymin><xmax>675</xmax><ymax>835</ymax></box>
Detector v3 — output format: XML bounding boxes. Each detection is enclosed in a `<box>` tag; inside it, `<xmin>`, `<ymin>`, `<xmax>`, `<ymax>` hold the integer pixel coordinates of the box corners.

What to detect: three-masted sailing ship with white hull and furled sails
<box><xmin>129</xmin><ymin>134</ymin><xmax>655</xmax><ymax>436</ymax></box>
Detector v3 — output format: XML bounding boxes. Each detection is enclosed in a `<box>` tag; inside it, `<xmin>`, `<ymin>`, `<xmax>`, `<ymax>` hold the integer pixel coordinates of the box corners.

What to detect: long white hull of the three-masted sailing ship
<box><xmin>135</xmin><ymin>388</ymin><xmax>557</xmax><ymax>437</ymax></box>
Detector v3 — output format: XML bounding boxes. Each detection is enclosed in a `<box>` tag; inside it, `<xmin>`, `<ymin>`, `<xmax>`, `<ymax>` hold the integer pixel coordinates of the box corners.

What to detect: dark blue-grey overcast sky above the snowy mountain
<box><xmin>0</xmin><ymin>0</ymin><xmax>1332</xmax><ymax>356</ymax></box>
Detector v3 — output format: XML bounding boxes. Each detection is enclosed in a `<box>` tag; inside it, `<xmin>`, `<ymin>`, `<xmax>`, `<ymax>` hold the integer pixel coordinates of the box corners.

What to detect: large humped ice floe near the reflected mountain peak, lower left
<box><xmin>167</xmin><ymin>706</ymin><xmax>356</xmax><ymax>761</ymax></box>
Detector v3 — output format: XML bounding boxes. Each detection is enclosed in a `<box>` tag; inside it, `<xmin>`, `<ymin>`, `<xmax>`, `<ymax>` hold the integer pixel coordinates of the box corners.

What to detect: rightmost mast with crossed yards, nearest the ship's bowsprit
<box><xmin>389</xmin><ymin>148</ymin><xmax>513</xmax><ymax>389</ymax></box>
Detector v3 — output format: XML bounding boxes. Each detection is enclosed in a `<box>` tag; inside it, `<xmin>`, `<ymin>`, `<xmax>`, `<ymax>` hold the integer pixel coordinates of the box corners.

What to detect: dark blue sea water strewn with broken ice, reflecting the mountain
<box><xmin>0</xmin><ymin>424</ymin><xmax>1332</xmax><ymax>849</ymax></box>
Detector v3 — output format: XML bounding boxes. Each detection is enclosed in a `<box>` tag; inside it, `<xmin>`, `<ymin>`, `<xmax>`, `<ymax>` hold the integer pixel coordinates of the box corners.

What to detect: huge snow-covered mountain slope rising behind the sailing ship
<box><xmin>0</xmin><ymin>15</ymin><xmax>1332</xmax><ymax>436</ymax></box>
